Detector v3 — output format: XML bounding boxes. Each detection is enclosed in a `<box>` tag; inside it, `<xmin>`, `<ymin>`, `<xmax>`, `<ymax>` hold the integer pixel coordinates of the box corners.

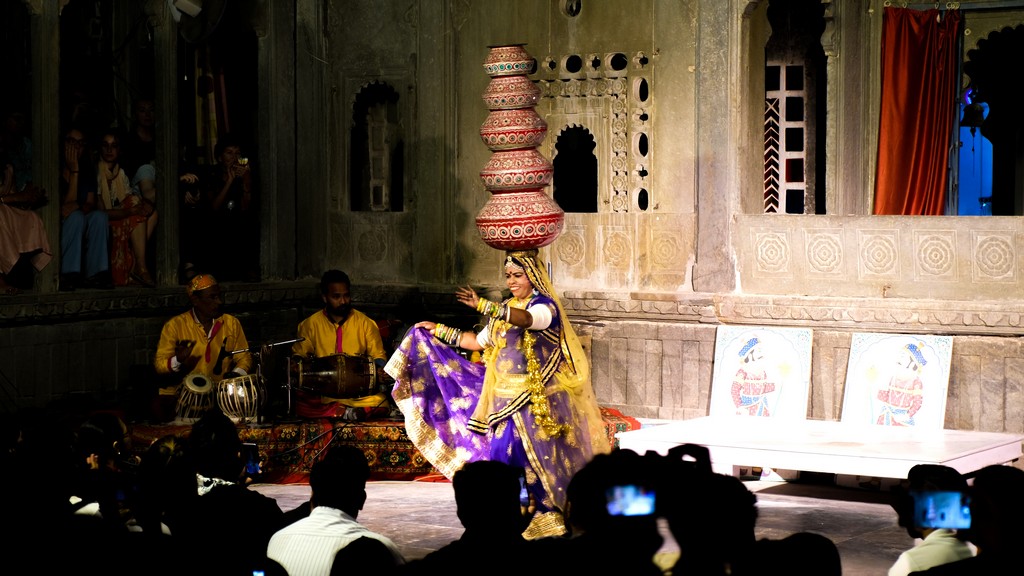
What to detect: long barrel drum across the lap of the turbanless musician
<box><xmin>296</xmin><ymin>354</ymin><xmax>377</xmax><ymax>400</ymax></box>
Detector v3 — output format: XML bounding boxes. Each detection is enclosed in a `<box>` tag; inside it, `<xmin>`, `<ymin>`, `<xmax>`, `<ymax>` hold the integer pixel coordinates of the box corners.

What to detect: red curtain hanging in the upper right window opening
<box><xmin>874</xmin><ymin>7</ymin><xmax>961</xmax><ymax>215</ymax></box>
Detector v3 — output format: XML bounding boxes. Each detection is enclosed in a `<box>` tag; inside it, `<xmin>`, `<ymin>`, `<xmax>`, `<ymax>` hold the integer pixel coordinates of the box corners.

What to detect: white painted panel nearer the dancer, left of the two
<box><xmin>709</xmin><ymin>325</ymin><xmax>813</xmax><ymax>420</ymax></box>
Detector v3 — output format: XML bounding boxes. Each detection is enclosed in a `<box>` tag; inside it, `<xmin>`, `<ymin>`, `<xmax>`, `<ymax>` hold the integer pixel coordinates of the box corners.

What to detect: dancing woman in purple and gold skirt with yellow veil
<box><xmin>385</xmin><ymin>250</ymin><xmax>608</xmax><ymax>538</ymax></box>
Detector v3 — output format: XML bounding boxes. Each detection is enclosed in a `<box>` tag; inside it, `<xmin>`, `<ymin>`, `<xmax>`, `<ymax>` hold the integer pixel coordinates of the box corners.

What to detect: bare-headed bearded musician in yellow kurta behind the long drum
<box><xmin>292</xmin><ymin>270</ymin><xmax>388</xmax><ymax>418</ymax></box>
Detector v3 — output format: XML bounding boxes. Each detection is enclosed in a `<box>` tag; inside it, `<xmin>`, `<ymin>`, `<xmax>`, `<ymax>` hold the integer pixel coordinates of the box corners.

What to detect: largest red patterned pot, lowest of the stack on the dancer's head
<box><xmin>476</xmin><ymin>190</ymin><xmax>565</xmax><ymax>250</ymax></box>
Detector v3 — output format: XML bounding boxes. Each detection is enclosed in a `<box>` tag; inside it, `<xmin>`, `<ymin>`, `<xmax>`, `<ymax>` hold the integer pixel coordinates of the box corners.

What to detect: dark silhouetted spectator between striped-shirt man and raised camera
<box><xmin>397</xmin><ymin>460</ymin><xmax>543</xmax><ymax>576</ymax></box>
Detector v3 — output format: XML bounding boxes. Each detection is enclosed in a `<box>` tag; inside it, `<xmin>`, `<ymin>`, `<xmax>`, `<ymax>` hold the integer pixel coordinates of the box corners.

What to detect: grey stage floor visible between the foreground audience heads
<box><xmin>254</xmin><ymin>473</ymin><xmax>913</xmax><ymax>576</ymax></box>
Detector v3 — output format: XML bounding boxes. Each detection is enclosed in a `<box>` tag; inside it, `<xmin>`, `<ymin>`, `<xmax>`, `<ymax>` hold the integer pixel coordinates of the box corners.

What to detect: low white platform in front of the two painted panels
<box><xmin>616</xmin><ymin>416</ymin><xmax>1024</xmax><ymax>479</ymax></box>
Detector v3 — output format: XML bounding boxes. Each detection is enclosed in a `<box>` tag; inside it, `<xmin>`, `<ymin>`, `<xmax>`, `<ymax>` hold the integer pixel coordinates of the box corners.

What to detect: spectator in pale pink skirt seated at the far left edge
<box><xmin>0</xmin><ymin>154</ymin><xmax>52</xmax><ymax>295</ymax></box>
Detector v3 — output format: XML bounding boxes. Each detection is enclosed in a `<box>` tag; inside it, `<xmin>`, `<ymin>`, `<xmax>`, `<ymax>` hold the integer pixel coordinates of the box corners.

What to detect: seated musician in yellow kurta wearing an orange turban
<box><xmin>154</xmin><ymin>274</ymin><xmax>253</xmax><ymax>416</ymax></box>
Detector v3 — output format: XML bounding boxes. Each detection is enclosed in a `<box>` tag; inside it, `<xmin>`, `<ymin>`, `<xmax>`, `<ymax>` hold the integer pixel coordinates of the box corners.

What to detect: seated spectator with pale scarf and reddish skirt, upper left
<box><xmin>96</xmin><ymin>130</ymin><xmax>156</xmax><ymax>288</ymax></box>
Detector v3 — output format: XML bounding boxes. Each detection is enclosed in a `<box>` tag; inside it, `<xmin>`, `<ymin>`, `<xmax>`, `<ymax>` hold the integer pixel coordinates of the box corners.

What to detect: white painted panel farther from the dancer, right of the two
<box><xmin>843</xmin><ymin>332</ymin><xmax>953</xmax><ymax>429</ymax></box>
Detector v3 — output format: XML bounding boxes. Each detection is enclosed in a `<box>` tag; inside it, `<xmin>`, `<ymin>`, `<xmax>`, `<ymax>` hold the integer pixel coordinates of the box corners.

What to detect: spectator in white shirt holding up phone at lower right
<box><xmin>889</xmin><ymin>464</ymin><xmax>974</xmax><ymax>576</ymax></box>
